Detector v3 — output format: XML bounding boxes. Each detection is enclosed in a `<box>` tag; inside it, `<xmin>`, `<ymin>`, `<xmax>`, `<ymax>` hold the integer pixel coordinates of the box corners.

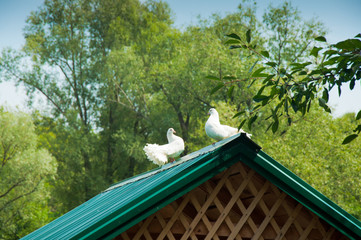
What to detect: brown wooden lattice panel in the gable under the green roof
<box><xmin>115</xmin><ymin>163</ymin><xmax>347</xmax><ymax>240</ymax></box>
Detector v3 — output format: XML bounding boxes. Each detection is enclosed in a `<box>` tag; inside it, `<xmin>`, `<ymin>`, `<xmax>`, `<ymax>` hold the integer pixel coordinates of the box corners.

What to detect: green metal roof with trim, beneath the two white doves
<box><xmin>23</xmin><ymin>134</ymin><xmax>361</xmax><ymax>239</ymax></box>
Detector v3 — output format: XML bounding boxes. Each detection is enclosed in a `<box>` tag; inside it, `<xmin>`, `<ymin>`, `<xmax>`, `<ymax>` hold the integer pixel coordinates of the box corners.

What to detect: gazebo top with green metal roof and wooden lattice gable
<box><xmin>24</xmin><ymin>135</ymin><xmax>361</xmax><ymax>240</ymax></box>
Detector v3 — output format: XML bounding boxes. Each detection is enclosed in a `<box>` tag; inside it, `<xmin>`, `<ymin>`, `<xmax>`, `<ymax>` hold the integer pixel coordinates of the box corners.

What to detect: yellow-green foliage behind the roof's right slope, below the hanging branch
<box><xmin>256</xmin><ymin>107</ymin><xmax>361</xmax><ymax>219</ymax></box>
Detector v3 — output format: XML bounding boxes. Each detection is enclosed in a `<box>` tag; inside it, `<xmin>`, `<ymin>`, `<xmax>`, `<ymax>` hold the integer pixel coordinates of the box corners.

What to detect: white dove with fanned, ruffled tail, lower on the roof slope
<box><xmin>143</xmin><ymin>128</ymin><xmax>184</xmax><ymax>166</ymax></box>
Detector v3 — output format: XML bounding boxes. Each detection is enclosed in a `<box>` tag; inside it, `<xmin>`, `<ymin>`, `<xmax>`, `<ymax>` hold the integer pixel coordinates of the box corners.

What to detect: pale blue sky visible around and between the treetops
<box><xmin>0</xmin><ymin>0</ymin><xmax>361</xmax><ymax>117</ymax></box>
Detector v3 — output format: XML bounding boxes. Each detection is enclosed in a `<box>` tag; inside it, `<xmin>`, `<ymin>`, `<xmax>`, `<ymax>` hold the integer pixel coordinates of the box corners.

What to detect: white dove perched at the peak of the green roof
<box><xmin>205</xmin><ymin>108</ymin><xmax>252</xmax><ymax>141</ymax></box>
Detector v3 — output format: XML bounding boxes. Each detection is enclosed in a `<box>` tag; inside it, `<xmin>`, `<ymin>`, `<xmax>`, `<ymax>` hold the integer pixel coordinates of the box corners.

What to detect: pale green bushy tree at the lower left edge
<box><xmin>0</xmin><ymin>108</ymin><xmax>56</xmax><ymax>239</ymax></box>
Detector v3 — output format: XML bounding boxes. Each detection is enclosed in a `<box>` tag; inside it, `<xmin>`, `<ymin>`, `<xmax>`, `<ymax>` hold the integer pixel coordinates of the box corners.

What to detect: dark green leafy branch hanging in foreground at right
<box><xmin>210</xmin><ymin>30</ymin><xmax>361</xmax><ymax>144</ymax></box>
